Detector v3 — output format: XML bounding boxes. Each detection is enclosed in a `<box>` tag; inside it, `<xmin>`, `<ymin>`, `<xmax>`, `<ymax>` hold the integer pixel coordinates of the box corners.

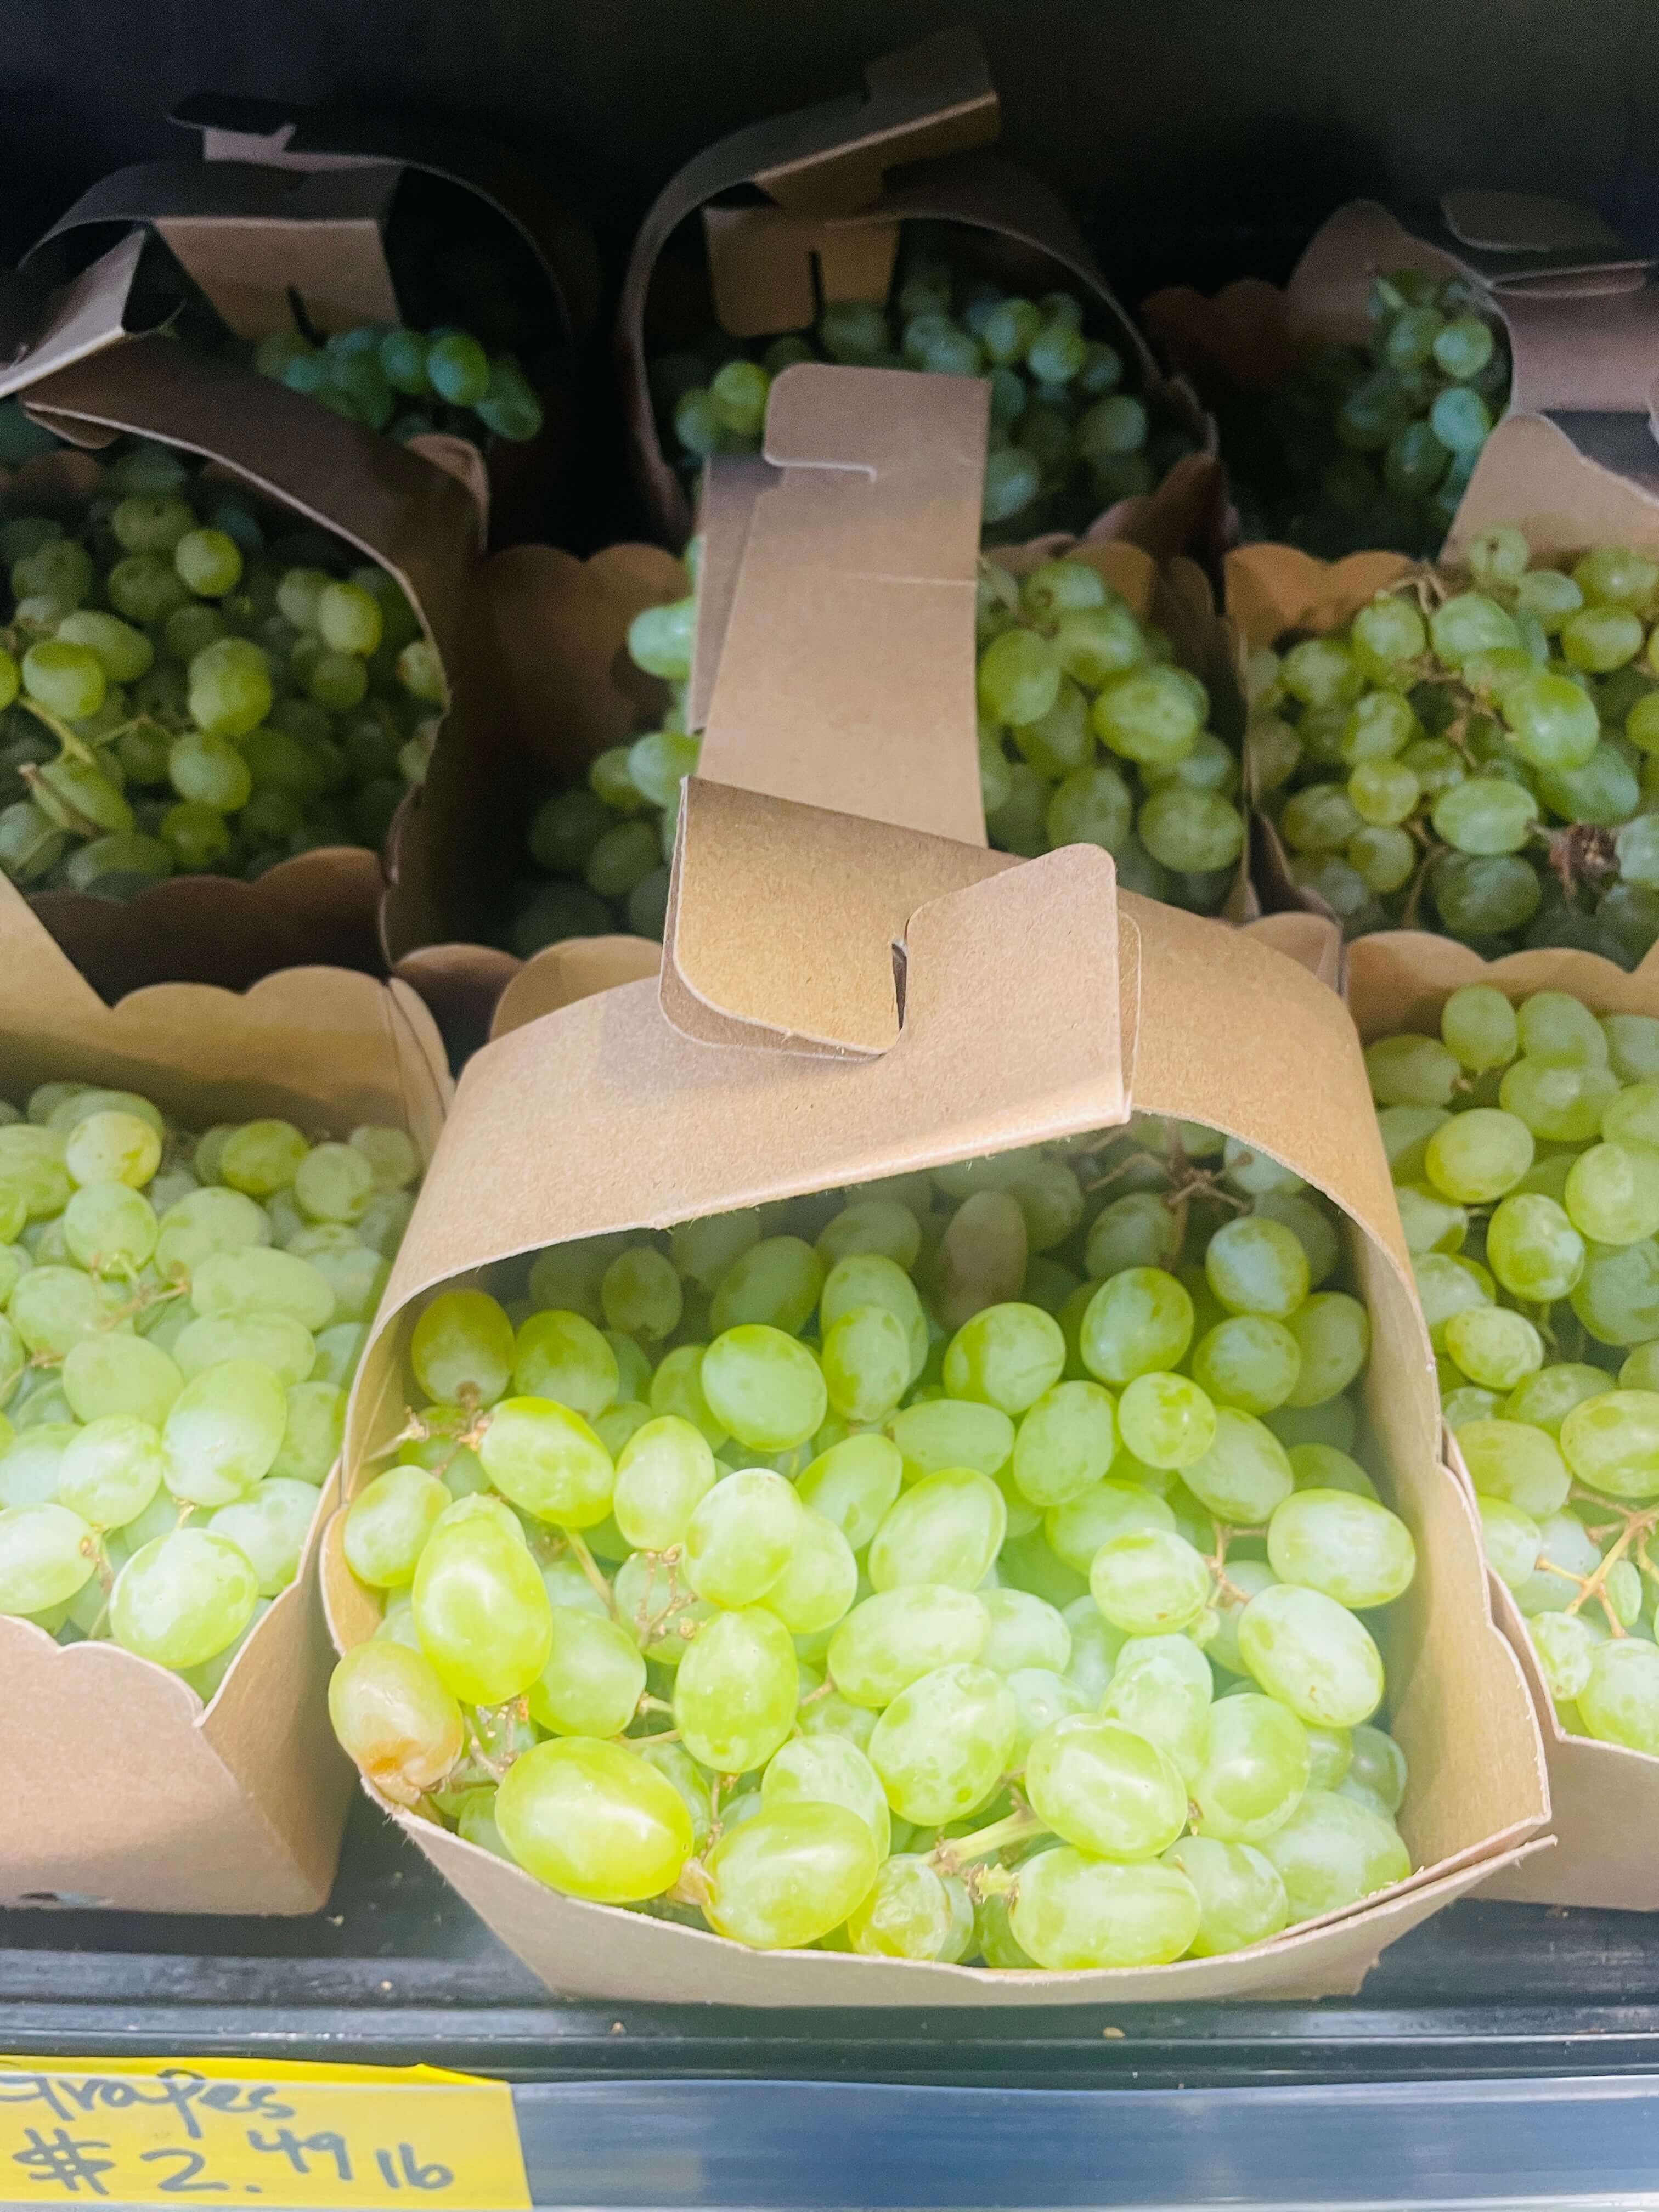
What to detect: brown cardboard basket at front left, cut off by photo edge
<box><xmin>0</xmin><ymin>883</ymin><xmax>449</xmax><ymax>1914</ymax></box>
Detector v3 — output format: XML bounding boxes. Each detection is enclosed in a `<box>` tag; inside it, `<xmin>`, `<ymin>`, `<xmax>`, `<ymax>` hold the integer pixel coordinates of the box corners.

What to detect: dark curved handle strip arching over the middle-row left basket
<box><xmin>22</xmin><ymin>336</ymin><xmax>480</xmax><ymax>670</ymax></box>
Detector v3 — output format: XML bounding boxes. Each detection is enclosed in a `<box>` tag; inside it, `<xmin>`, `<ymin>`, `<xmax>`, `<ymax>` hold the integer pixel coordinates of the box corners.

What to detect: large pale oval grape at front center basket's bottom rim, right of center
<box><xmin>1009</xmin><ymin>1847</ymin><xmax>1203</xmax><ymax>1971</ymax></box>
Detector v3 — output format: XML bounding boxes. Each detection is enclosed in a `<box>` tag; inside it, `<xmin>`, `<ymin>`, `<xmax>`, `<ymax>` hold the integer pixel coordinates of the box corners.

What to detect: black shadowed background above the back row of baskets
<box><xmin>13</xmin><ymin>0</ymin><xmax>1659</xmax><ymax>298</ymax></box>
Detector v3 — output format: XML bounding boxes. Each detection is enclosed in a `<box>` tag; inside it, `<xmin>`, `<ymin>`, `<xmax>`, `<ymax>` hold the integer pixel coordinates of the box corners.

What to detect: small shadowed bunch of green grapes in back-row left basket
<box><xmin>252</xmin><ymin>323</ymin><xmax>542</xmax><ymax>444</ymax></box>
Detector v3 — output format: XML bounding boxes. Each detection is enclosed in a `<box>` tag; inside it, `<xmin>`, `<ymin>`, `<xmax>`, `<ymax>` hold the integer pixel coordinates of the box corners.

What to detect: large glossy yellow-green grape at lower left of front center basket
<box><xmin>495</xmin><ymin>1736</ymin><xmax>692</xmax><ymax>1905</ymax></box>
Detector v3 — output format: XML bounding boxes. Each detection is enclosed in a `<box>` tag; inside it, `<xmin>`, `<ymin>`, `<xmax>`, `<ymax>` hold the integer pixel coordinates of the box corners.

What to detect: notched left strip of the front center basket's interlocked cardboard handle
<box><xmin>349</xmin><ymin>836</ymin><xmax>1132</xmax><ymax>1371</ymax></box>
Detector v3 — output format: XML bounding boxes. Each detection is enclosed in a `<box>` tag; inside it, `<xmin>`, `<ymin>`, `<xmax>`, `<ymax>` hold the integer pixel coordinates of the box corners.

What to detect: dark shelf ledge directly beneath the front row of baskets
<box><xmin>0</xmin><ymin>1803</ymin><xmax>1659</xmax><ymax>2092</ymax></box>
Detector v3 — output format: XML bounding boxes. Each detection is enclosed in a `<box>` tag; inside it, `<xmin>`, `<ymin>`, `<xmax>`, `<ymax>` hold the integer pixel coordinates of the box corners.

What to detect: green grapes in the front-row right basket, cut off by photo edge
<box><xmin>1365</xmin><ymin>984</ymin><xmax>1659</xmax><ymax>1754</ymax></box>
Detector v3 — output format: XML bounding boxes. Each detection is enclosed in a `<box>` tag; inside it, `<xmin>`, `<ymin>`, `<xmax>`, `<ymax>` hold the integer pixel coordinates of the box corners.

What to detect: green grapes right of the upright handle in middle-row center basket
<box><xmin>978</xmin><ymin>560</ymin><xmax>1245</xmax><ymax>913</ymax></box>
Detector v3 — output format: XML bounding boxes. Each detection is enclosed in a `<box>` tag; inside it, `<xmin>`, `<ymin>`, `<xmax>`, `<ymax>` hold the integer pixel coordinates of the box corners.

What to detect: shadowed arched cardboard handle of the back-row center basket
<box><xmin>617</xmin><ymin>29</ymin><xmax>1226</xmax><ymax>553</ymax></box>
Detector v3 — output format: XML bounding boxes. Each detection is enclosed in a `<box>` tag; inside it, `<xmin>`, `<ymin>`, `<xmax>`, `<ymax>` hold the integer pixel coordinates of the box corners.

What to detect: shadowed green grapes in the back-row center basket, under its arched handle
<box><xmin>650</xmin><ymin>244</ymin><xmax>1194</xmax><ymax>544</ymax></box>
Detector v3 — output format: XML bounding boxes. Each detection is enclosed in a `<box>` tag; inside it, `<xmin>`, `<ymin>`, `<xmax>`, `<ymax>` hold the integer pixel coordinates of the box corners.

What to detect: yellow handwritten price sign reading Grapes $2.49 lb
<box><xmin>0</xmin><ymin>2057</ymin><xmax>531</xmax><ymax>2212</ymax></box>
